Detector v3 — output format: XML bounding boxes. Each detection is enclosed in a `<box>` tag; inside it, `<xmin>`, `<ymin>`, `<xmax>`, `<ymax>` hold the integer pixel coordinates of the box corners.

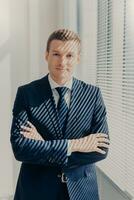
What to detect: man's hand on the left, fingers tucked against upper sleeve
<box><xmin>20</xmin><ymin>121</ymin><xmax>44</xmax><ymax>141</ymax></box>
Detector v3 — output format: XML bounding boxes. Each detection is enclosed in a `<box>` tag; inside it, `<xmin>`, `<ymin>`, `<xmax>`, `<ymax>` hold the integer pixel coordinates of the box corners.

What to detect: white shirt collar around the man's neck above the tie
<box><xmin>48</xmin><ymin>74</ymin><xmax>73</xmax><ymax>90</ymax></box>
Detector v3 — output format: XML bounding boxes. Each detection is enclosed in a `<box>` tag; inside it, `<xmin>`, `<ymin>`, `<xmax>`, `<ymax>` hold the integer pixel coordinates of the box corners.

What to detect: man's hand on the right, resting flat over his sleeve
<box><xmin>70</xmin><ymin>133</ymin><xmax>110</xmax><ymax>154</ymax></box>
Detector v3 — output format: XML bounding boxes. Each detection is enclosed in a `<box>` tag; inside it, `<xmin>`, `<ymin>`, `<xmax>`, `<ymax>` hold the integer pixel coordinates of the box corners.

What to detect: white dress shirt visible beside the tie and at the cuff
<box><xmin>48</xmin><ymin>74</ymin><xmax>73</xmax><ymax>156</ymax></box>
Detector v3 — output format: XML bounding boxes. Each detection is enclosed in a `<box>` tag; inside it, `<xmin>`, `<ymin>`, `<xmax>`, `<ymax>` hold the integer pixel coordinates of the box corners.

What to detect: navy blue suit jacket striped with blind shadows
<box><xmin>11</xmin><ymin>75</ymin><xmax>108</xmax><ymax>200</ymax></box>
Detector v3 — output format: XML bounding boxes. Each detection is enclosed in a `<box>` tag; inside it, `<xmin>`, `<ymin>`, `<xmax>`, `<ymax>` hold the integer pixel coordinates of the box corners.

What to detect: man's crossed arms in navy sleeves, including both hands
<box><xmin>11</xmin><ymin>86</ymin><xmax>109</xmax><ymax>168</ymax></box>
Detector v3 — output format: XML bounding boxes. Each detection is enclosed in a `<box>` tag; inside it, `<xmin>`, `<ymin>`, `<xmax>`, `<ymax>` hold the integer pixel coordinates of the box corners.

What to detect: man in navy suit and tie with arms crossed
<box><xmin>11</xmin><ymin>29</ymin><xmax>109</xmax><ymax>200</ymax></box>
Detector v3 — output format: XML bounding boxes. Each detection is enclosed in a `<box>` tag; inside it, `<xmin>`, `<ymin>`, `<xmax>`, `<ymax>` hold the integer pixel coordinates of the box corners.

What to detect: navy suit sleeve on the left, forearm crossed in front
<box><xmin>10</xmin><ymin>87</ymin><xmax>68</xmax><ymax>166</ymax></box>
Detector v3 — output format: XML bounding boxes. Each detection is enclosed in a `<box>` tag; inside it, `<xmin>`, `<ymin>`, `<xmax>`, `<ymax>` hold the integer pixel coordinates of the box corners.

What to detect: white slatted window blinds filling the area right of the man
<box><xmin>96</xmin><ymin>0</ymin><xmax>134</xmax><ymax>197</ymax></box>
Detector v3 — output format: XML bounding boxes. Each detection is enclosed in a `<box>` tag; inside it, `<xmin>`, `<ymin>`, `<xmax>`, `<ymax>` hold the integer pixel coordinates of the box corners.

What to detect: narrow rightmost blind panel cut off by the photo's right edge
<box><xmin>122</xmin><ymin>0</ymin><xmax>134</xmax><ymax>197</ymax></box>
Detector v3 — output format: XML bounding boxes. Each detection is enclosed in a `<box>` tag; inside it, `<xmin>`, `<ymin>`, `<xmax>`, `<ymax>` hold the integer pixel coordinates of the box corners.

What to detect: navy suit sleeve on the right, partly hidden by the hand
<box><xmin>67</xmin><ymin>88</ymin><xmax>108</xmax><ymax>168</ymax></box>
